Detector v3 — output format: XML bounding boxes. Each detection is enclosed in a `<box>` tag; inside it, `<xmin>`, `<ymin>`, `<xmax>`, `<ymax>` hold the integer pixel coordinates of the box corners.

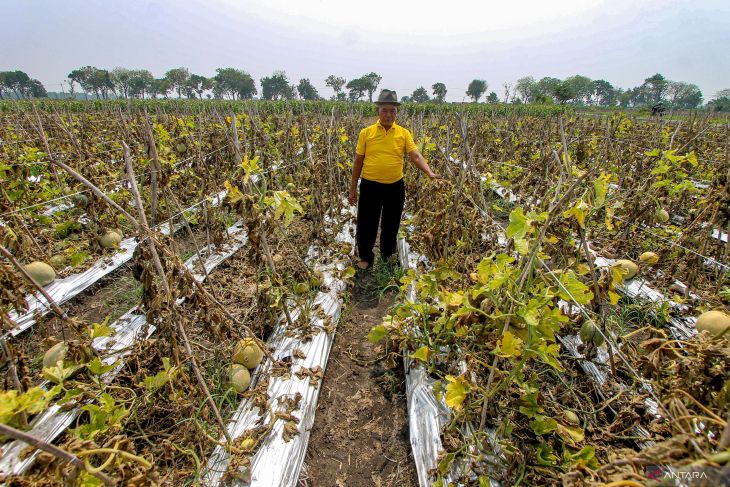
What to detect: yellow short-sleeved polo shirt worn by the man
<box><xmin>355</xmin><ymin>120</ymin><xmax>417</xmax><ymax>184</ymax></box>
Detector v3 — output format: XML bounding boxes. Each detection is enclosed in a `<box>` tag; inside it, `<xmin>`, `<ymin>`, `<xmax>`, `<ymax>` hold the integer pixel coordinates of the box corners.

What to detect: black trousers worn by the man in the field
<box><xmin>357</xmin><ymin>179</ymin><xmax>406</xmax><ymax>264</ymax></box>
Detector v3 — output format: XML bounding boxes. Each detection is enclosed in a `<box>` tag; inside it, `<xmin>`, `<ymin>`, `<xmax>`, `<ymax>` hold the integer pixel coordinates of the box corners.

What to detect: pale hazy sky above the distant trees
<box><xmin>0</xmin><ymin>0</ymin><xmax>730</xmax><ymax>101</ymax></box>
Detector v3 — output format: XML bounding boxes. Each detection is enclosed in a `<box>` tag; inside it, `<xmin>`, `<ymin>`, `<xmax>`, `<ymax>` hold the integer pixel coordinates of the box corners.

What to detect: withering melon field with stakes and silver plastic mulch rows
<box><xmin>0</xmin><ymin>101</ymin><xmax>730</xmax><ymax>487</ymax></box>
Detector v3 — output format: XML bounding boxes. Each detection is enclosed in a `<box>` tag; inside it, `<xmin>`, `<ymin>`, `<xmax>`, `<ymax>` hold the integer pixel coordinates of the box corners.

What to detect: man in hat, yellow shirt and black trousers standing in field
<box><xmin>349</xmin><ymin>90</ymin><xmax>436</xmax><ymax>269</ymax></box>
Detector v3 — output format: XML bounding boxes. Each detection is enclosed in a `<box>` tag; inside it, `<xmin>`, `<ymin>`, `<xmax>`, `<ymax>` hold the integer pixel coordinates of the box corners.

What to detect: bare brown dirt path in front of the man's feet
<box><xmin>299</xmin><ymin>273</ymin><xmax>418</xmax><ymax>487</ymax></box>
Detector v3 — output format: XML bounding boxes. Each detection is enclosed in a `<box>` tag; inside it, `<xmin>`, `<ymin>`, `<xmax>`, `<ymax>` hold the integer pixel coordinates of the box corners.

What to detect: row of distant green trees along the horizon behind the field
<box><xmin>0</xmin><ymin>66</ymin><xmax>730</xmax><ymax>111</ymax></box>
